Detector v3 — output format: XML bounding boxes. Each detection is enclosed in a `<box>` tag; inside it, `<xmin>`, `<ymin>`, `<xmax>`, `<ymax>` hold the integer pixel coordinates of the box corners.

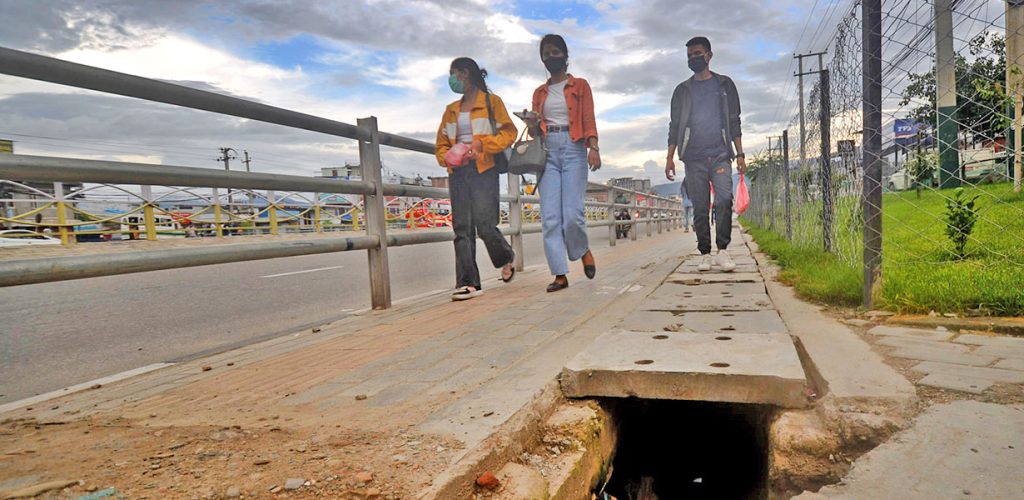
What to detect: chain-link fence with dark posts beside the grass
<box><xmin>748</xmin><ymin>0</ymin><xmax>1024</xmax><ymax>314</ymax></box>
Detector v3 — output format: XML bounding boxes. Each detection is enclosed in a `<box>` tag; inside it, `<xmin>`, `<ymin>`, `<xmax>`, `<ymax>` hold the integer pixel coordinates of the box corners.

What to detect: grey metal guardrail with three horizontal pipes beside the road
<box><xmin>0</xmin><ymin>47</ymin><xmax>682</xmax><ymax>308</ymax></box>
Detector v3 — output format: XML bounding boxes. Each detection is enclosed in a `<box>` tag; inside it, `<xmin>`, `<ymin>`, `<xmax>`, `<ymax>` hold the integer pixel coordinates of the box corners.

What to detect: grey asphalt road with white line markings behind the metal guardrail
<box><xmin>0</xmin><ymin>227</ymin><xmax>634</xmax><ymax>404</ymax></box>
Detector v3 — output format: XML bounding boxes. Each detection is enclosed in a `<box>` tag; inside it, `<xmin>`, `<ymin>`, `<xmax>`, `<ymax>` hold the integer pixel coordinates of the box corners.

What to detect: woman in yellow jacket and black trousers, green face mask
<box><xmin>434</xmin><ymin>57</ymin><xmax>518</xmax><ymax>300</ymax></box>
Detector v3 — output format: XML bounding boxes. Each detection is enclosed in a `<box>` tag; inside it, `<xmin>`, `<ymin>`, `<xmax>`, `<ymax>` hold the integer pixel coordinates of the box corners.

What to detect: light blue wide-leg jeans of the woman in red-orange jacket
<box><xmin>540</xmin><ymin>131</ymin><xmax>590</xmax><ymax>276</ymax></box>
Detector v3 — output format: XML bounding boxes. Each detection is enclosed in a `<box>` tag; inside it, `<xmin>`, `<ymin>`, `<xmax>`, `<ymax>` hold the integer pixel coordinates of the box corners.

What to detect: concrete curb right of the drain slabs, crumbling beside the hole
<box><xmin>743</xmin><ymin>234</ymin><xmax>918</xmax><ymax>496</ymax></box>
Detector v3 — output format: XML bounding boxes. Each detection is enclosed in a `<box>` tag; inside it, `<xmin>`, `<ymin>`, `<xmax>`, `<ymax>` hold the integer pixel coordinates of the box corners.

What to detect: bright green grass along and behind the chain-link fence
<box><xmin>745</xmin><ymin>183</ymin><xmax>1024</xmax><ymax>316</ymax></box>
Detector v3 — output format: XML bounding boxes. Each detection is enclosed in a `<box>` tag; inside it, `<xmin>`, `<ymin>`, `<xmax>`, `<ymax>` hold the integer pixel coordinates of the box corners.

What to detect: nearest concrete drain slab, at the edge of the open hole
<box><xmin>561</xmin><ymin>331</ymin><xmax>808</xmax><ymax>408</ymax></box>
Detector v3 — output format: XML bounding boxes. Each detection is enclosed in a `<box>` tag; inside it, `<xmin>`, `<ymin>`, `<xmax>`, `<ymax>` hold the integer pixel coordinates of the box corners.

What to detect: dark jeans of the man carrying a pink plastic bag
<box><xmin>684</xmin><ymin>159</ymin><xmax>732</xmax><ymax>254</ymax></box>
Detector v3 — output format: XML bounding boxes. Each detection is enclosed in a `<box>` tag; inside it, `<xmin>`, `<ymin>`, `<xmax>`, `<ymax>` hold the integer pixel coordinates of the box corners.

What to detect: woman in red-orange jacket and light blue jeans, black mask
<box><xmin>530</xmin><ymin>35</ymin><xmax>601</xmax><ymax>292</ymax></box>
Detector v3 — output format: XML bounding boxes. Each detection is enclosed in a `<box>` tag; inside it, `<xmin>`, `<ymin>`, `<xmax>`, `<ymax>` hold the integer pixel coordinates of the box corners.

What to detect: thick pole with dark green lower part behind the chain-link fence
<box><xmin>935</xmin><ymin>0</ymin><xmax>961</xmax><ymax>188</ymax></box>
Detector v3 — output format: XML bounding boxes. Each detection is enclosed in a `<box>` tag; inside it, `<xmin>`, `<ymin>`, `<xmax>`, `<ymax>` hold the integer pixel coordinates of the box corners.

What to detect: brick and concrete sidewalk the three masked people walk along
<box><xmin>6</xmin><ymin>222</ymin><xmax>1024</xmax><ymax>498</ymax></box>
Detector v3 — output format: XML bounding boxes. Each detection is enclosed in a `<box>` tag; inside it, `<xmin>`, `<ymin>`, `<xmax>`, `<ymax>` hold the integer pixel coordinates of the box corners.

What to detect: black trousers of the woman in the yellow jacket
<box><xmin>449</xmin><ymin>162</ymin><xmax>512</xmax><ymax>290</ymax></box>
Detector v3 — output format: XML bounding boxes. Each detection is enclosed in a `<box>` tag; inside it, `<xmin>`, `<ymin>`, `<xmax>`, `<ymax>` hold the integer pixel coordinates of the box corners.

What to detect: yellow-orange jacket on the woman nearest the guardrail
<box><xmin>434</xmin><ymin>91</ymin><xmax>519</xmax><ymax>173</ymax></box>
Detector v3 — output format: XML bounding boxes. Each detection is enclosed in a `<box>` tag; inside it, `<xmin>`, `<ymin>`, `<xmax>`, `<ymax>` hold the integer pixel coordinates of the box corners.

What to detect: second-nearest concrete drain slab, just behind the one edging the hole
<box><xmin>618</xmin><ymin>309</ymin><xmax>786</xmax><ymax>334</ymax></box>
